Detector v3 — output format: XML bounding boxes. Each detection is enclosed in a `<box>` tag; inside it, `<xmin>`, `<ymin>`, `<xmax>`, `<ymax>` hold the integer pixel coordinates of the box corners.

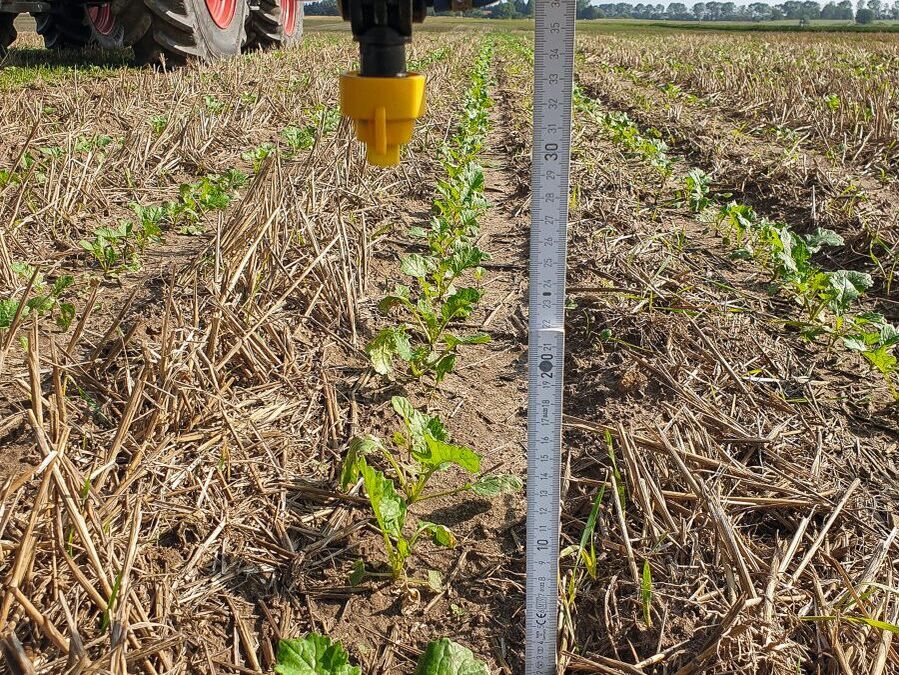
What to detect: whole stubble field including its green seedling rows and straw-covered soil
<box><xmin>0</xmin><ymin>14</ymin><xmax>899</xmax><ymax>675</ymax></box>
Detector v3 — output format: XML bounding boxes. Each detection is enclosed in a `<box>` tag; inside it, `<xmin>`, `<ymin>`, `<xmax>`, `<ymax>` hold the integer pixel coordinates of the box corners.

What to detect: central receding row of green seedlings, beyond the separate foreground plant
<box><xmin>366</xmin><ymin>44</ymin><xmax>493</xmax><ymax>384</ymax></box>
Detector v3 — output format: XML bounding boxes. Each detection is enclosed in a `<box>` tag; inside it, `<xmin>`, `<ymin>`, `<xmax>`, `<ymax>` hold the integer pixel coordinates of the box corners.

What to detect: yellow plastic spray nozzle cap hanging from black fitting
<box><xmin>340</xmin><ymin>72</ymin><xmax>425</xmax><ymax>166</ymax></box>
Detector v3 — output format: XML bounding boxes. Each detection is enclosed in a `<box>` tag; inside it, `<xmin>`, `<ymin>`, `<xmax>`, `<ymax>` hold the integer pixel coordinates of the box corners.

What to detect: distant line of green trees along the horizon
<box><xmin>306</xmin><ymin>0</ymin><xmax>899</xmax><ymax>23</ymax></box>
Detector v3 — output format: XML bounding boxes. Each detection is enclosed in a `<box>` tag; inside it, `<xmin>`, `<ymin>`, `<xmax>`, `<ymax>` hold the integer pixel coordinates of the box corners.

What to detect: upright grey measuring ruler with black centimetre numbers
<box><xmin>525</xmin><ymin>0</ymin><xmax>577</xmax><ymax>675</ymax></box>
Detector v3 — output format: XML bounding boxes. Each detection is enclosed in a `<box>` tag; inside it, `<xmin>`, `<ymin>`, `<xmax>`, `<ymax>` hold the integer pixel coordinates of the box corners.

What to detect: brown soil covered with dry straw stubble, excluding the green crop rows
<box><xmin>0</xmin><ymin>15</ymin><xmax>899</xmax><ymax>674</ymax></box>
